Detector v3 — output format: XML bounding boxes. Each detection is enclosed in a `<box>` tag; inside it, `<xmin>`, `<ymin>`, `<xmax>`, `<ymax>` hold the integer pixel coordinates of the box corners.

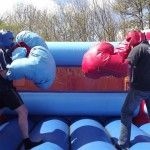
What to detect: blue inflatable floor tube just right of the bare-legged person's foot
<box><xmin>22</xmin><ymin>118</ymin><xmax>69</xmax><ymax>150</ymax></box>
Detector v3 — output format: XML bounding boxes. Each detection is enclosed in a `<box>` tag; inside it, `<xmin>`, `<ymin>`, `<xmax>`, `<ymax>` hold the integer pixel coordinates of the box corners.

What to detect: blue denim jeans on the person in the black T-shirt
<box><xmin>118</xmin><ymin>88</ymin><xmax>150</xmax><ymax>148</ymax></box>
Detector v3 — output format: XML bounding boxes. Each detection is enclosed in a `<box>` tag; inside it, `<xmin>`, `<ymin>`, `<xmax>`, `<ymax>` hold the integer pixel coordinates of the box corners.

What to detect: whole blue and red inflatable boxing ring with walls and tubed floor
<box><xmin>0</xmin><ymin>42</ymin><xmax>150</xmax><ymax>150</ymax></box>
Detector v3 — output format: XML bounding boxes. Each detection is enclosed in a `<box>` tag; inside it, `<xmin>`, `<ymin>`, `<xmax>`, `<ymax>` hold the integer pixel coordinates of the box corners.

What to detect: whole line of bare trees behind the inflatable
<box><xmin>0</xmin><ymin>0</ymin><xmax>150</xmax><ymax>42</ymax></box>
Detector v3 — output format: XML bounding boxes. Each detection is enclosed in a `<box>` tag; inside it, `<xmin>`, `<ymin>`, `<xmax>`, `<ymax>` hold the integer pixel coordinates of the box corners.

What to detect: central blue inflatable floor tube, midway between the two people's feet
<box><xmin>70</xmin><ymin>119</ymin><xmax>115</xmax><ymax>150</ymax></box>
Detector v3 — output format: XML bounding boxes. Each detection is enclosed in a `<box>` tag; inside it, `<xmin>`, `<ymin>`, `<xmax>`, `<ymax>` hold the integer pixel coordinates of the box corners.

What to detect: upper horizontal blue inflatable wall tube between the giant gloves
<box><xmin>46</xmin><ymin>42</ymin><xmax>118</xmax><ymax>66</ymax></box>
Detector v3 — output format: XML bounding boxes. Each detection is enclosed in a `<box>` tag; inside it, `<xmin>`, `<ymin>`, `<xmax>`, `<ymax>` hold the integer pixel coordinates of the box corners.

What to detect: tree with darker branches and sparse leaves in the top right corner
<box><xmin>113</xmin><ymin>0</ymin><xmax>150</xmax><ymax>30</ymax></box>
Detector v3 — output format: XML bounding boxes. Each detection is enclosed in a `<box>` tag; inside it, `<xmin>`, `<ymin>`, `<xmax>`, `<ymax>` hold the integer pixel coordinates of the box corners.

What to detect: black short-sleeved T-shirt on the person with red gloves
<box><xmin>128</xmin><ymin>42</ymin><xmax>150</xmax><ymax>91</ymax></box>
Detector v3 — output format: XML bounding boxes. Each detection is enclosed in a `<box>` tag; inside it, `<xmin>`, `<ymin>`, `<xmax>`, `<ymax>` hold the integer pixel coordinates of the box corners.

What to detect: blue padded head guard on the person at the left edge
<box><xmin>0</xmin><ymin>30</ymin><xmax>14</xmax><ymax>49</ymax></box>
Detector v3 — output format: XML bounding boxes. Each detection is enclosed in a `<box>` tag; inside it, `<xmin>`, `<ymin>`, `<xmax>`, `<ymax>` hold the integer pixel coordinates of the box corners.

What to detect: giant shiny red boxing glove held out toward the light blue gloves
<box><xmin>82</xmin><ymin>42</ymin><xmax>128</xmax><ymax>79</ymax></box>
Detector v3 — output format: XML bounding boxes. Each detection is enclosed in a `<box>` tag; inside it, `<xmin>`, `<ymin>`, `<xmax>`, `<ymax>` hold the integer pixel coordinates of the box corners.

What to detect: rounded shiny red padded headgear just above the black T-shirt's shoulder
<box><xmin>126</xmin><ymin>31</ymin><xmax>145</xmax><ymax>47</ymax></box>
